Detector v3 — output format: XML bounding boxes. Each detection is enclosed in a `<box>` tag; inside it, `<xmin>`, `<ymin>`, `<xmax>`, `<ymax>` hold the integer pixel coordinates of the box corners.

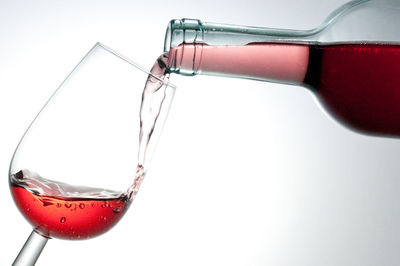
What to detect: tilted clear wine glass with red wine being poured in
<box><xmin>9</xmin><ymin>43</ymin><xmax>175</xmax><ymax>265</ymax></box>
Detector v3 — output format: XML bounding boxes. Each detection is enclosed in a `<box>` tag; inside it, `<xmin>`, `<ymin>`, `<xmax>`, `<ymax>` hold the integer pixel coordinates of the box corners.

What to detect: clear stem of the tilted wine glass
<box><xmin>12</xmin><ymin>230</ymin><xmax>48</xmax><ymax>266</ymax></box>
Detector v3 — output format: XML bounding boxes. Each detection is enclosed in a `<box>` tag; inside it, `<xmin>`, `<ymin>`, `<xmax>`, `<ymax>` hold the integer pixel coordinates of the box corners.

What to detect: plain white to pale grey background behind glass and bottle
<box><xmin>0</xmin><ymin>0</ymin><xmax>400</xmax><ymax>266</ymax></box>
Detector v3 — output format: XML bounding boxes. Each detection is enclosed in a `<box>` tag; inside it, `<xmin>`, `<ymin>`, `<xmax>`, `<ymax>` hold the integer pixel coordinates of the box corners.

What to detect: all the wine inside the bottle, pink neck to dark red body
<box><xmin>168</xmin><ymin>43</ymin><xmax>400</xmax><ymax>137</ymax></box>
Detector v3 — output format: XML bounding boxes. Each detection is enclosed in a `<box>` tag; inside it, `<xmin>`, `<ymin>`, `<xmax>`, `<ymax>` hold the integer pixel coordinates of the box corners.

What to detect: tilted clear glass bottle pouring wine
<box><xmin>164</xmin><ymin>0</ymin><xmax>400</xmax><ymax>137</ymax></box>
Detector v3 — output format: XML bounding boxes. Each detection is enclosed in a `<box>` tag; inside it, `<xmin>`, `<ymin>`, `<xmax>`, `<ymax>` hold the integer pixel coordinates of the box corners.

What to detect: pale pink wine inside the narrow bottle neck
<box><xmin>168</xmin><ymin>43</ymin><xmax>309</xmax><ymax>82</ymax></box>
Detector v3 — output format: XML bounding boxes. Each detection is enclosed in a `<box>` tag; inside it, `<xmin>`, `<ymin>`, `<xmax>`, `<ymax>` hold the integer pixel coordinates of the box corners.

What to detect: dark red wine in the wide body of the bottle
<box><xmin>304</xmin><ymin>44</ymin><xmax>400</xmax><ymax>137</ymax></box>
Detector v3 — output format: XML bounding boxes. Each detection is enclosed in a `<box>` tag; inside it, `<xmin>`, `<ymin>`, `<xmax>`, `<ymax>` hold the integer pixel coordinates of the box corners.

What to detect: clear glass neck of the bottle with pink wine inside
<box><xmin>164</xmin><ymin>19</ymin><xmax>315</xmax><ymax>84</ymax></box>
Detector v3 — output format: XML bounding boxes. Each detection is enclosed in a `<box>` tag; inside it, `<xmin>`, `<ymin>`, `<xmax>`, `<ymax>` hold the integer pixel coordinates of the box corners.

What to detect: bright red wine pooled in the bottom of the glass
<box><xmin>10</xmin><ymin>170</ymin><xmax>131</xmax><ymax>239</ymax></box>
